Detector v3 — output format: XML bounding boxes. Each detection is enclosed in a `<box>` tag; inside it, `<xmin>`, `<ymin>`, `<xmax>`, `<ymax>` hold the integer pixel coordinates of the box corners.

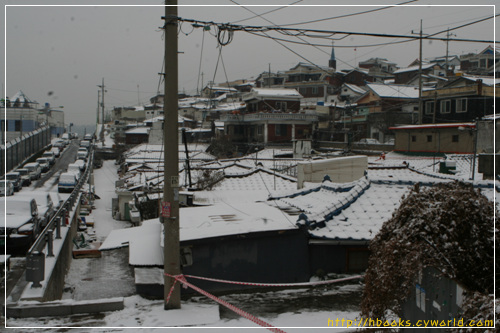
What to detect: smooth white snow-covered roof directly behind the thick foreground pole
<box><xmin>100</xmin><ymin>203</ymin><xmax>297</xmax><ymax>266</ymax></box>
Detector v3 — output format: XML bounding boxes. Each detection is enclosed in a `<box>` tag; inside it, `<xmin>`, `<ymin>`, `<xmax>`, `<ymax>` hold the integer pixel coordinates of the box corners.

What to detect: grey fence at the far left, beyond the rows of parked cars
<box><xmin>0</xmin><ymin>126</ymin><xmax>51</xmax><ymax>176</ymax></box>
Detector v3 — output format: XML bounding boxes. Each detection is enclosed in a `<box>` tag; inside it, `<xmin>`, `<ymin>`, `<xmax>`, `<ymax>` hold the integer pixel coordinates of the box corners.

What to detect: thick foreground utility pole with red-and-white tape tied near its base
<box><xmin>161</xmin><ymin>0</ymin><xmax>181</xmax><ymax>310</ymax></box>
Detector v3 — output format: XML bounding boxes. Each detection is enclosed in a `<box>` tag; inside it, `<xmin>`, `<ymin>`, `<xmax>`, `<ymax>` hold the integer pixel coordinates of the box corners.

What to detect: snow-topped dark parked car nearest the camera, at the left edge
<box><xmin>0</xmin><ymin>197</ymin><xmax>41</xmax><ymax>255</ymax></box>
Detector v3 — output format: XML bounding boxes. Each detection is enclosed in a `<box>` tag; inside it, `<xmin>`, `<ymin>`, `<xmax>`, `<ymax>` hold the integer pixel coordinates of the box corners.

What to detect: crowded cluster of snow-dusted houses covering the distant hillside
<box><xmin>107</xmin><ymin>47</ymin><xmax>499</xmax><ymax>158</ymax></box>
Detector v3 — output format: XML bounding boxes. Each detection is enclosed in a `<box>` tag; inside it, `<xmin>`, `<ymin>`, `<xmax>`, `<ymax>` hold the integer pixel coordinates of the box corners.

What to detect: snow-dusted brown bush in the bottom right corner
<box><xmin>361</xmin><ymin>182</ymin><xmax>498</xmax><ymax>326</ymax></box>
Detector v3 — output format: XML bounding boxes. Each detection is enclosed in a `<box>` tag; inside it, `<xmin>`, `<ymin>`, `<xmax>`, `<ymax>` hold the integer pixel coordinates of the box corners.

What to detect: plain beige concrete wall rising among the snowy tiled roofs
<box><xmin>297</xmin><ymin>156</ymin><xmax>368</xmax><ymax>189</ymax></box>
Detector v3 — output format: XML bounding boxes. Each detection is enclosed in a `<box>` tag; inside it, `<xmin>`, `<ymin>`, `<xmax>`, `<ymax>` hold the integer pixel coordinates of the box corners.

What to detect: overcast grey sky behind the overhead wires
<box><xmin>2</xmin><ymin>0</ymin><xmax>500</xmax><ymax>125</ymax></box>
